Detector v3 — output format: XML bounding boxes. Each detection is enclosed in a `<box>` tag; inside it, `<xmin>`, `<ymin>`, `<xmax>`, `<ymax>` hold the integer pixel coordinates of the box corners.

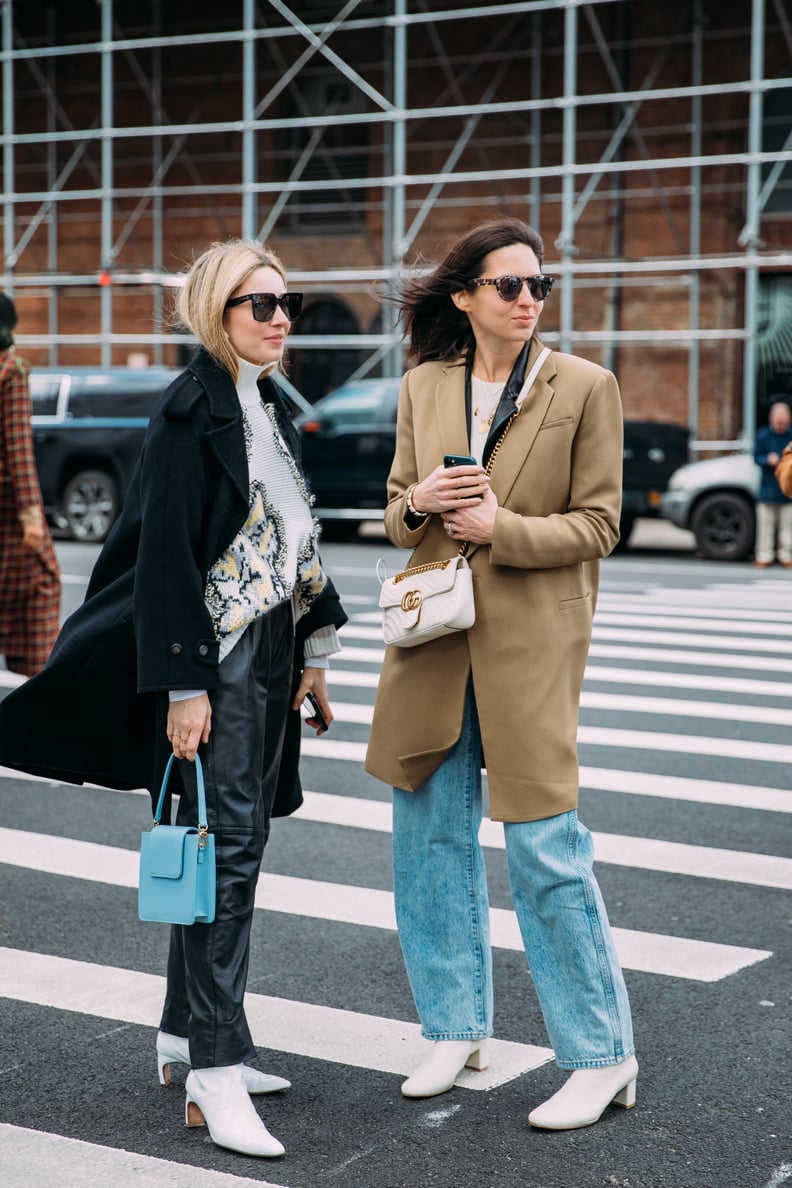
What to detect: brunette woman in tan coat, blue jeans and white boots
<box><xmin>367</xmin><ymin>219</ymin><xmax>638</xmax><ymax>1130</ymax></box>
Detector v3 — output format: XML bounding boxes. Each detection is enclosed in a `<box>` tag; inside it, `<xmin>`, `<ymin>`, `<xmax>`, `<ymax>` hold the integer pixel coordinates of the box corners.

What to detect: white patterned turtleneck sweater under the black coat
<box><xmin>171</xmin><ymin>359</ymin><xmax>341</xmax><ymax>701</ymax></box>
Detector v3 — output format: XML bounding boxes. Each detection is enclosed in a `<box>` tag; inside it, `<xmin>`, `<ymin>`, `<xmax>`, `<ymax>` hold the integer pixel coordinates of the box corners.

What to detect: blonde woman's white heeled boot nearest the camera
<box><xmin>184</xmin><ymin>1064</ymin><xmax>285</xmax><ymax>1158</ymax></box>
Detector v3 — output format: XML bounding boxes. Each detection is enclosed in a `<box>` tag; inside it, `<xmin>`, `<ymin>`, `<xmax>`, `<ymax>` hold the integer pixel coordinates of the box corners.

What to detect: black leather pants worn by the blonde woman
<box><xmin>160</xmin><ymin>604</ymin><xmax>293</xmax><ymax>1068</ymax></box>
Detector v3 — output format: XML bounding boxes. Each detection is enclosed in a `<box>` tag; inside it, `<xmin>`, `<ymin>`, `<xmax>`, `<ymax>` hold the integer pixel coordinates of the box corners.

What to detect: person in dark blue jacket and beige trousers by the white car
<box><xmin>754</xmin><ymin>400</ymin><xmax>792</xmax><ymax>569</ymax></box>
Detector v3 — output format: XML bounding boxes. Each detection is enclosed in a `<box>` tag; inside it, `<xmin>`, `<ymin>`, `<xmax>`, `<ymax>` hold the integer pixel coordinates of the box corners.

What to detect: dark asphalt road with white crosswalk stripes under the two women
<box><xmin>0</xmin><ymin>524</ymin><xmax>792</xmax><ymax>1188</ymax></box>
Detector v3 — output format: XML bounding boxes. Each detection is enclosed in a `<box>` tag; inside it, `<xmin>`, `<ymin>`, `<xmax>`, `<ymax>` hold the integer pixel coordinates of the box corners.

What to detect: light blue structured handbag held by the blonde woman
<box><xmin>138</xmin><ymin>754</ymin><xmax>216</xmax><ymax>924</ymax></box>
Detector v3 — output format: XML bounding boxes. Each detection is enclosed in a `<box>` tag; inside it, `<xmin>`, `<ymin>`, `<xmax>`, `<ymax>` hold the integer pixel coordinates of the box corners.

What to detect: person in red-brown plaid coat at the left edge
<box><xmin>0</xmin><ymin>293</ymin><xmax>61</xmax><ymax>676</ymax></box>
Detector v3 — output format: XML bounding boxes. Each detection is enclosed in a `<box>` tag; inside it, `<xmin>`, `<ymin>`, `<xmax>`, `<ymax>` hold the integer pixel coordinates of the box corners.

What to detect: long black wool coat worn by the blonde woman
<box><xmin>0</xmin><ymin>350</ymin><xmax>347</xmax><ymax>816</ymax></box>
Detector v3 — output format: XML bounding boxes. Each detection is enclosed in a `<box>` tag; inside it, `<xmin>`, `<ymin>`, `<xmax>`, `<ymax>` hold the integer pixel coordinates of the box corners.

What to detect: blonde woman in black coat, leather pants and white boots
<box><xmin>0</xmin><ymin>240</ymin><xmax>346</xmax><ymax>1156</ymax></box>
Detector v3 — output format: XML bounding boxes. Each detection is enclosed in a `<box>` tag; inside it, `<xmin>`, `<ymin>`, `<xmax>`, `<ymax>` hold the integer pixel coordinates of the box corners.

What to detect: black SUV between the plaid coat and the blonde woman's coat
<box><xmin>30</xmin><ymin>367</ymin><xmax>178</xmax><ymax>541</ymax></box>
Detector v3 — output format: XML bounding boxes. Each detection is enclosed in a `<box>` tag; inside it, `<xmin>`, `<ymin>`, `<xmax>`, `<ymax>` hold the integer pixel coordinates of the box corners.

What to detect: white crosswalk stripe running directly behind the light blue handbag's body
<box><xmin>0</xmin><ymin>828</ymin><xmax>772</xmax><ymax>981</ymax></box>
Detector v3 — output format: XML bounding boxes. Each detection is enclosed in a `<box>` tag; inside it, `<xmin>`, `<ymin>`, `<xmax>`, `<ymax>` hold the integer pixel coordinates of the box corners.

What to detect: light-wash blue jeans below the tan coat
<box><xmin>393</xmin><ymin>687</ymin><xmax>634</xmax><ymax>1068</ymax></box>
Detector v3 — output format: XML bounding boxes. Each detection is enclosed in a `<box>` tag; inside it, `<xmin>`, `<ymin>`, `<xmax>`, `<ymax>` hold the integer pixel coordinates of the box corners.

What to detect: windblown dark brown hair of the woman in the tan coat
<box><xmin>392</xmin><ymin>219</ymin><xmax>544</xmax><ymax>364</ymax></box>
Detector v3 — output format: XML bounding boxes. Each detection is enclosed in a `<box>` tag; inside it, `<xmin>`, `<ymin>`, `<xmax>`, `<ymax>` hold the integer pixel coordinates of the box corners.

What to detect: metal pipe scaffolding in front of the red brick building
<box><xmin>0</xmin><ymin>0</ymin><xmax>792</xmax><ymax>448</ymax></box>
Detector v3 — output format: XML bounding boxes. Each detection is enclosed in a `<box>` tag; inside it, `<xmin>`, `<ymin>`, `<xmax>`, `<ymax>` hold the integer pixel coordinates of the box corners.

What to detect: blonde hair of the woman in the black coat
<box><xmin>176</xmin><ymin>239</ymin><xmax>286</xmax><ymax>383</ymax></box>
